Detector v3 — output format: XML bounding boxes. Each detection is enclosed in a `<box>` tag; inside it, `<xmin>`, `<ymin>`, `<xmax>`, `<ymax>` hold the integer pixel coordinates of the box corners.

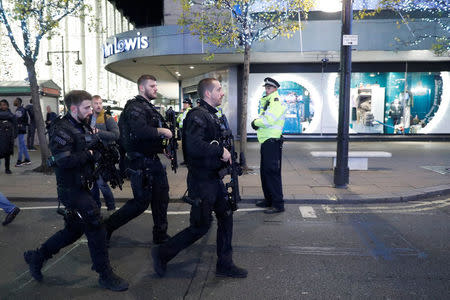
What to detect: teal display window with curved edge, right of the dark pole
<box><xmin>342</xmin><ymin>72</ymin><xmax>443</xmax><ymax>134</ymax></box>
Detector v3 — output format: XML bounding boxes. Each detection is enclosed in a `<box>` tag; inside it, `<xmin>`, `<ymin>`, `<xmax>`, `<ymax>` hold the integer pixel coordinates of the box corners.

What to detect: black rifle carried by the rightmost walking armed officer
<box><xmin>219</xmin><ymin>115</ymin><xmax>245</xmax><ymax>211</ymax></box>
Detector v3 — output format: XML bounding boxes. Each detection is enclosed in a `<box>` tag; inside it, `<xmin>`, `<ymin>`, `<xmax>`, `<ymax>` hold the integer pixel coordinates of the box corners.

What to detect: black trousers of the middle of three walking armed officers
<box><xmin>105</xmin><ymin>156</ymin><xmax>169</xmax><ymax>240</ymax></box>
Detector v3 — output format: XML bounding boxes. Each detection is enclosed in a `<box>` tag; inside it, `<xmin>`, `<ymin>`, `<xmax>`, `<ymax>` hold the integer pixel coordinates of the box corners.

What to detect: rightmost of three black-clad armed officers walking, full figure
<box><xmin>152</xmin><ymin>78</ymin><xmax>247</xmax><ymax>278</ymax></box>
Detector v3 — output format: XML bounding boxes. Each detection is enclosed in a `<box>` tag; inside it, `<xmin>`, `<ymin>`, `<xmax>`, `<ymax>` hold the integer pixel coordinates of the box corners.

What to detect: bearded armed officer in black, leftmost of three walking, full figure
<box><xmin>24</xmin><ymin>90</ymin><xmax>128</xmax><ymax>291</ymax></box>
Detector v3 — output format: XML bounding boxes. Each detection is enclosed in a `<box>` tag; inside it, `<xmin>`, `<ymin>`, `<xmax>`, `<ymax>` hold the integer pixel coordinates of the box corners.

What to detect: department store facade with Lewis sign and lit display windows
<box><xmin>104</xmin><ymin>1</ymin><xmax>450</xmax><ymax>135</ymax></box>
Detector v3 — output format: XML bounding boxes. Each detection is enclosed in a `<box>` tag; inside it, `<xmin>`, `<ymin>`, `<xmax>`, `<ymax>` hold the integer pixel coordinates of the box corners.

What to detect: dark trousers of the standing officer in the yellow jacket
<box><xmin>260</xmin><ymin>139</ymin><xmax>284</xmax><ymax>208</ymax></box>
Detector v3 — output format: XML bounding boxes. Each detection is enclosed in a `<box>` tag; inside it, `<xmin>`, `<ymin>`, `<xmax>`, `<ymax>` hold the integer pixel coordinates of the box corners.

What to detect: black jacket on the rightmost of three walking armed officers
<box><xmin>183</xmin><ymin>100</ymin><xmax>223</xmax><ymax>178</ymax></box>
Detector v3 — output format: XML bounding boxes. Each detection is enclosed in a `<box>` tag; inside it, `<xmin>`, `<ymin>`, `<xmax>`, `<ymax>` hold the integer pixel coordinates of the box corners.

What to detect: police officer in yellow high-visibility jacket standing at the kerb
<box><xmin>252</xmin><ymin>77</ymin><xmax>286</xmax><ymax>214</ymax></box>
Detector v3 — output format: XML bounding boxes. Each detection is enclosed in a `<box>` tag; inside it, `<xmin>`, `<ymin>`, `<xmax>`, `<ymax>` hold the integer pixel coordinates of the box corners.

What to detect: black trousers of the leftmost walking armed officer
<box><xmin>39</xmin><ymin>190</ymin><xmax>110</xmax><ymax>273</ymax></box>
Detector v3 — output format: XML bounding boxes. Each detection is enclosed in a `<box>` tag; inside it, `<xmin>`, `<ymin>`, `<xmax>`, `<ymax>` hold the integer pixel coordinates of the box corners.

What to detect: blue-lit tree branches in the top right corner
<box><xmin>359</xmin><ymin>0</ymin><xmax>450</xmax><ymax>55</ymax></box>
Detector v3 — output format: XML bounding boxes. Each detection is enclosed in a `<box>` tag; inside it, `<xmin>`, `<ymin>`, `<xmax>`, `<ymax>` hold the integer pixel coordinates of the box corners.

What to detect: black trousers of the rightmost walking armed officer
<box><xmin>160</xmin><ymin>173</ymin><xmax>233</xmax><ymax>267</ymax></box>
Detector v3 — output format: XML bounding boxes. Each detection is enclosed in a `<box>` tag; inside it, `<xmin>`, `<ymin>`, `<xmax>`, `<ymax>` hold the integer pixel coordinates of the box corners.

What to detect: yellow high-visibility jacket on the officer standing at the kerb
<box><xmin>254</xmin><ymin>91</ymin><xmax>287</xmax><ymax>144</ymax></box>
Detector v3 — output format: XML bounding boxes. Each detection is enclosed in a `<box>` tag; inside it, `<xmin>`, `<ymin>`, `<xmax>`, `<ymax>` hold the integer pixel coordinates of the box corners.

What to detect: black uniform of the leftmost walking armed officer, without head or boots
<box><xmin>26</xmin><ymin>114</ymin><xmax>111</xmax><ymax>276</ymax></box>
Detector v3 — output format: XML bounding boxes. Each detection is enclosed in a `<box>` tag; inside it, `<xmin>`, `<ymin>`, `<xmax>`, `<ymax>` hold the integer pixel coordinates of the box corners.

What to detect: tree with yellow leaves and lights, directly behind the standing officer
<box><xmin>178</xmin><ymin>0</ymin><xmax>314</xmax><ymax>169</ymax></box>
